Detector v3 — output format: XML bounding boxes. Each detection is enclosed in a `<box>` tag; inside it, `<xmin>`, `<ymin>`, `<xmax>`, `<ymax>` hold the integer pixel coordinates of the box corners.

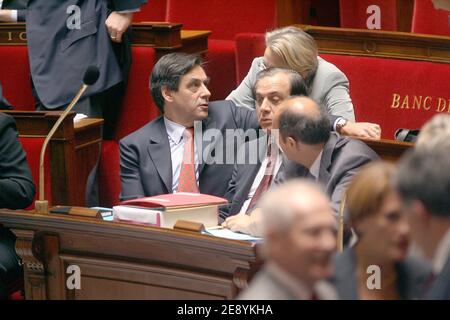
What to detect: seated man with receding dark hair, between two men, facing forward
<box><xmin>221</xmin><ymin>68</ymin><xmax>306</xmax><ymax>222</ymax></box>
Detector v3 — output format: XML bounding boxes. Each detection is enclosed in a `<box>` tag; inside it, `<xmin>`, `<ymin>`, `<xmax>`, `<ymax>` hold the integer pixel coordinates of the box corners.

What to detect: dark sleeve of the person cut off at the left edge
<box><xmin>0</xmin><ymin>113</ymin><xmax>35</xmax><ymax>209</ymax></box>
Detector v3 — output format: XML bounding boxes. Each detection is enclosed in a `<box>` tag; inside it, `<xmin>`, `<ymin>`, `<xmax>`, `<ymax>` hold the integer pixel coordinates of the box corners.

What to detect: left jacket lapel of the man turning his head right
<box><xmin>148</xmin><ymin>117</ymin><xmax>172</xmax><ymax>193</ymax></box>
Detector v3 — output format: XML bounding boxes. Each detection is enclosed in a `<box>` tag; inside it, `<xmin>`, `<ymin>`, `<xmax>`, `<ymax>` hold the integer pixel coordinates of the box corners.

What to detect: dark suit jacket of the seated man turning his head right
<box><xmin>120</xmin><ymin>101</ymin><xmax>259</xmax><ymax>200</ymax></box>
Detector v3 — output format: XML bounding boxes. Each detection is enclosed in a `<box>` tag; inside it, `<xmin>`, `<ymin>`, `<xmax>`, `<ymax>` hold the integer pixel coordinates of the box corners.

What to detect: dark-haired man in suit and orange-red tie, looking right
<box><xmin>120</xmin><ymin>53</ymin><xmax>259</xmax><ymax>200</ymax></box>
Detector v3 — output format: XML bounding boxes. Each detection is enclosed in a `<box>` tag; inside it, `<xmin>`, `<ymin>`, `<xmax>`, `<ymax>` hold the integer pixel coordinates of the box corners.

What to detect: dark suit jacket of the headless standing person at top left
<box><xmin>26</xmin><ymin>0</ymin><xmax>145</xmax><ymax>109</ymax></box>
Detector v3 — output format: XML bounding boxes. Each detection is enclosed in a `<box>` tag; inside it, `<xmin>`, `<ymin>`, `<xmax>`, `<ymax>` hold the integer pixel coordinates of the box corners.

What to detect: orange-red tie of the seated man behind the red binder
<box><xmin>178</xmin><ymin>128</ymin><xmax>199</xmax><ymax>193</ymax></box>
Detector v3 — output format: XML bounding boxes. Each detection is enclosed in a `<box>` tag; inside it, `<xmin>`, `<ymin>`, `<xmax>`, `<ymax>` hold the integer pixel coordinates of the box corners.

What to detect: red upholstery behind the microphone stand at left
<box><xmin>19</xmin><ymin>137</ymin><xmax>52</xmax><ymax>210</ymax></box>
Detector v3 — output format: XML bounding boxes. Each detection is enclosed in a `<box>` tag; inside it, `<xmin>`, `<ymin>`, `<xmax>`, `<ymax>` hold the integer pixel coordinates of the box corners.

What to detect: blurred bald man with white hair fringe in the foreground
<box><xmin>238</xmin><ymin>179</ymin><xmax>336</xmax><ymax>300</ymax></box>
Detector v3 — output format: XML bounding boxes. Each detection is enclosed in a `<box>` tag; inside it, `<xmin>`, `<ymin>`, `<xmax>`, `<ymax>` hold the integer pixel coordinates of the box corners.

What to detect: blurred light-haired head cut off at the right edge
<box><xmin>416</xmin><ymin>114</ymin><xmax>450</xmax><ymax>150</ymax></box>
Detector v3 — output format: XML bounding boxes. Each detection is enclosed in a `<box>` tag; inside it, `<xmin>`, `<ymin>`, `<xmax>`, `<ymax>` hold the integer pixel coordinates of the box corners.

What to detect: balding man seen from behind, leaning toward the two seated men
<box><xmin>273</xmin><ymin>97</ymin><xmax>378</xmax><ymax>222</ymax></box>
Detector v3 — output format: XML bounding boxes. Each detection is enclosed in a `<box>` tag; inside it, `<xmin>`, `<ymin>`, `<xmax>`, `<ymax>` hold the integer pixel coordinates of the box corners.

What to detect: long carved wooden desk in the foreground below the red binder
<box><xmin>0</xmin><ymin>210</ymin><xmax>261</xmax><ymax>299</ymax></box>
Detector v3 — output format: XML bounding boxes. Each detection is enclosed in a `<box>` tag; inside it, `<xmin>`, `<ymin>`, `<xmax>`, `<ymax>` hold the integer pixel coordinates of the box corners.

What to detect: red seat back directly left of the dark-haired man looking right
<box><xmin>114</xmin><ymin>47</ymin><xmax>159</xmax><ymax>141</ymax></box>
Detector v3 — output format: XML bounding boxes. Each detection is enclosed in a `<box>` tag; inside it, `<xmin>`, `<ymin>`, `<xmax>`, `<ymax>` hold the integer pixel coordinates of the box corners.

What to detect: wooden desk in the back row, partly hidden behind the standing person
<box><xmin>0</xmin><ymin>22</ymin><xmax>211</xmax><ymax>57</ymax></box>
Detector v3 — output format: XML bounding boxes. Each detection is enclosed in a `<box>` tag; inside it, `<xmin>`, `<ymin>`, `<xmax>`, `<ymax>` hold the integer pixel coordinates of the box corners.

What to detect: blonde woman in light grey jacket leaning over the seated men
<box><xmin>226</xmin><ymin>26</ymin><xmax>381</xmax><ymax>138</ymax></box>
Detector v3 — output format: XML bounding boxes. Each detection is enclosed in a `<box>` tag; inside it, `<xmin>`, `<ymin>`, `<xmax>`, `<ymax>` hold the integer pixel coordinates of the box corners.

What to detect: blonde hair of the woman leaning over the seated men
<box><xmin>266</xmin><ymin>27</ymin><xmax>318</xmax><ymax>83</ymax></box>
